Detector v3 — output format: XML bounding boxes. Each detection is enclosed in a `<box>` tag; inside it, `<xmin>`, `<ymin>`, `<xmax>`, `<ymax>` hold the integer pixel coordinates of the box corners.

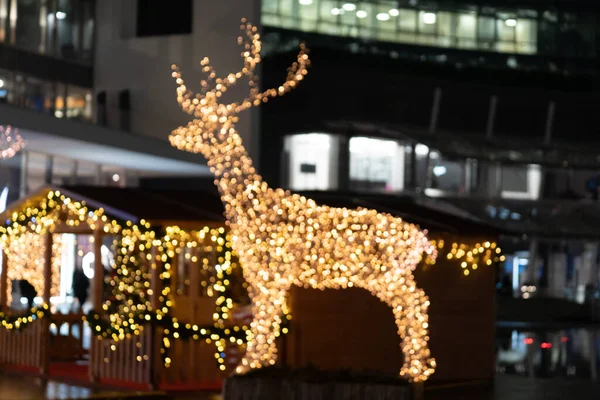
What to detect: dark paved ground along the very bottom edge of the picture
<box><xmin>0</xmin><ymin>375</ymin><xmax>600</xmax><ymax>400</ymax></box>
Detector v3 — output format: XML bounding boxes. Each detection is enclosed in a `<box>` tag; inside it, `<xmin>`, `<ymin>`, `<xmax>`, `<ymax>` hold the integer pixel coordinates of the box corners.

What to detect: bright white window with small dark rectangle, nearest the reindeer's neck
<box><xmin>284</xmin><ymin>133</ymin><xmax>339</xmax><ymax>190</ymax></box>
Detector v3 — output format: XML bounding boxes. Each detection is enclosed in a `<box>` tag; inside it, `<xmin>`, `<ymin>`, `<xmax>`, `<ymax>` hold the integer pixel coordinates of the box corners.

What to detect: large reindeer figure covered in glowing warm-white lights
<box><xmin>170</xmin><ymin>19</ymin><xmax>436</xmax><ymax>382</ymax></box>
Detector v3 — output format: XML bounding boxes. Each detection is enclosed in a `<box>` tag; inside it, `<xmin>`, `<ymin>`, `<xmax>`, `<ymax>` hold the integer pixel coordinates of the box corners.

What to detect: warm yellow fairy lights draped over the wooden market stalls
<box><xmin>0</xmin><ymin>186</ymin><xmax>503</xmax><ymax>371</ymax></box>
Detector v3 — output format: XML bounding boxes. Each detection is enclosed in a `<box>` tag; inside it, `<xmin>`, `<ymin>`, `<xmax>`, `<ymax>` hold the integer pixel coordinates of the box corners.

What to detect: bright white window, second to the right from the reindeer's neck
<box><xmin>350</xmin><ymin>137</ymin><xmax>405</xmax><ymax>191</ymax></box>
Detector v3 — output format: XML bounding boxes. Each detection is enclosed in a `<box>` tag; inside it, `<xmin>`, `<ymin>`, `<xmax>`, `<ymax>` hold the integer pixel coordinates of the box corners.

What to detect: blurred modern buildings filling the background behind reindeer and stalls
<box><xmin>0</xmin><ymin>0</ymin><xmax>600</xmax><ymax>302</ymax></box>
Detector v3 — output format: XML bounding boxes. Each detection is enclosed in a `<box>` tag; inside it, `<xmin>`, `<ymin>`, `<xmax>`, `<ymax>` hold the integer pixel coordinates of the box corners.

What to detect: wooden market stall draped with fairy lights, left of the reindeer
<box><xmin>0</xmin><ymin>187</ymin><xmax>247</xmax><ymax>389</ymax></box>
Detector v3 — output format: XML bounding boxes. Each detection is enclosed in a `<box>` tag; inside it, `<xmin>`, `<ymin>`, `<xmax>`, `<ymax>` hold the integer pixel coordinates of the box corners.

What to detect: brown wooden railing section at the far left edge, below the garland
<box><xmin>0</xmin><ymin>319</ymin><xmax>48</xmax><ymax>370</ymax></box>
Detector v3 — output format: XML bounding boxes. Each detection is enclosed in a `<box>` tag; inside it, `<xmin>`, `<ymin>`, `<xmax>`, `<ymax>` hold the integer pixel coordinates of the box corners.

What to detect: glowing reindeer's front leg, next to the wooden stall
<box><xmin>236</xmin><ymin>282</ymin><xmax>287</xmax><ymax>373</ymax></box>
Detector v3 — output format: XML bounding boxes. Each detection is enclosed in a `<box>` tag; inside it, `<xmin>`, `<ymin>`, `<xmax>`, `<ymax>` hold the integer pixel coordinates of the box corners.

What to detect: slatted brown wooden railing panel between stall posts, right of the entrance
<box><xmin>89</xmin><ymin>327</ymin><xmax>153</xmax><ymax>386</ymax></box>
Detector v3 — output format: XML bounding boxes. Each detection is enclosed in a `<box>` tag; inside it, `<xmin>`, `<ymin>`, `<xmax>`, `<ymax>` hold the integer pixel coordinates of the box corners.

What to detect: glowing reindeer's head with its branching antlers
<box><xmin>169</xmin><ymin>19</ymin><xmax>310</xmax><ymax>154</ymax></box>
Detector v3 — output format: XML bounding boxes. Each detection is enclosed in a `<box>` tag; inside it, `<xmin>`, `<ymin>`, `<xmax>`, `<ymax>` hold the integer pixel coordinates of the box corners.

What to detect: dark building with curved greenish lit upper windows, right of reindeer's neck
<box><xmin>255</xmin><ymin>0</ymin><xmax>600</xmax><ymax>301</ymax></box>
